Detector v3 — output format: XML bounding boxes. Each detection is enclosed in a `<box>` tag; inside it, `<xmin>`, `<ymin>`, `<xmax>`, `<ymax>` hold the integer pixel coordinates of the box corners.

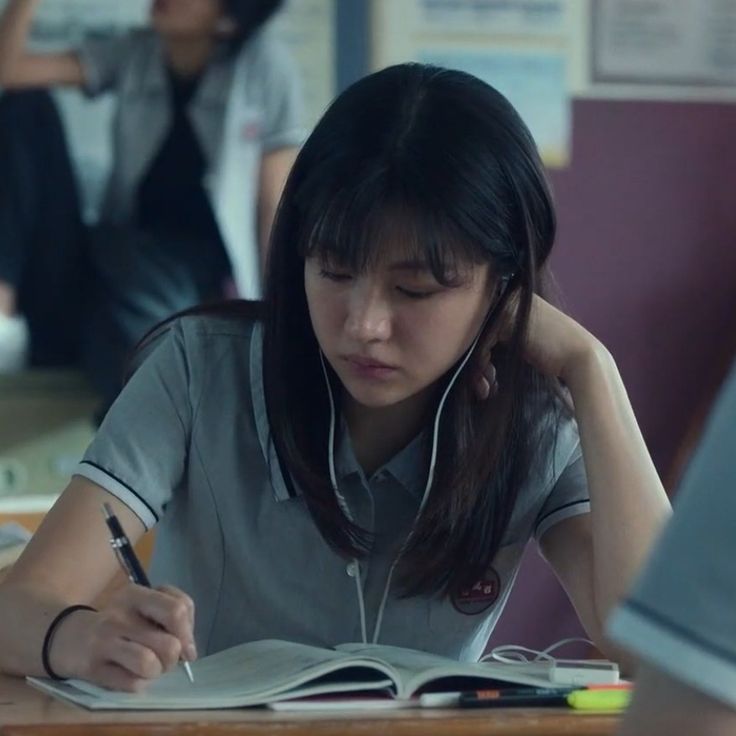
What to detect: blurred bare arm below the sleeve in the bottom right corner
<box><xmin>619</xmin><ymin>665</ymin><xmax>736</xmax><ymax>736</ymax></box>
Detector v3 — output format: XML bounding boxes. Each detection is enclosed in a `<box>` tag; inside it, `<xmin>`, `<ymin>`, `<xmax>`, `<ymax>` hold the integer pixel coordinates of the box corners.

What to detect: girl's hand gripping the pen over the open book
<box><xmin>49</xmin><ymin>583</ymin><xmax>197</xmax><ymax>692</ymax></box>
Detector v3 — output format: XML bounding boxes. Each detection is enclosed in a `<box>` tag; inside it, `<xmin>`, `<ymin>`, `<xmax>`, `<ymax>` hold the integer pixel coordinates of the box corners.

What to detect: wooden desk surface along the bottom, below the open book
<box><xmin>0</xmin><ymin>675</ymin><xmax>617</xmax><ymax>736</ymax></box>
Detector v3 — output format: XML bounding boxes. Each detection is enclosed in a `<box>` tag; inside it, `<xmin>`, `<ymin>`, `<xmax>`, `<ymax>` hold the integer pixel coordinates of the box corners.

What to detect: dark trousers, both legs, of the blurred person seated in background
<box><xmin>0</xmin><ymin>91</ymin><xmax>228</xmax><ymax>412</ymax></box>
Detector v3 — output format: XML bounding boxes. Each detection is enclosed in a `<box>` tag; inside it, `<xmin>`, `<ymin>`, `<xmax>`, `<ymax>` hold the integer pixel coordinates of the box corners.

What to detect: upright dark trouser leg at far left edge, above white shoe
<box><xmin>0</xmin><ymin>91</ymin><xmax>87</xmax><ymax>366</ymax></box>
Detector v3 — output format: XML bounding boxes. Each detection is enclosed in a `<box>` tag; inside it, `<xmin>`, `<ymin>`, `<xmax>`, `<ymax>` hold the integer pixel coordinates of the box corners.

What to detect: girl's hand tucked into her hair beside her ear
<box><xmin>475</xmin><ymin>295</ymin><xmax>602</xmax><ymax>399</ymax></box>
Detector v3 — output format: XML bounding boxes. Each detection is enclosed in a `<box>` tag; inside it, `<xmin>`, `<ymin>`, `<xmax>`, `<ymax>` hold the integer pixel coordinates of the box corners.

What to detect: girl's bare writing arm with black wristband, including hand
<box><xmin>0</xmin><ymin>476</ymin><xmax>196</xmax><ymax>690</ymax></box>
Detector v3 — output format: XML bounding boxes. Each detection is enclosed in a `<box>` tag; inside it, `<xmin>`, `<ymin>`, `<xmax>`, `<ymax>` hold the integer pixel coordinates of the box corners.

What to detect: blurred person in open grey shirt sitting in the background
<box><xmin>0</xmin><ymin>0</ymin><xmax>303</xmax><ymax>396</ymax></box>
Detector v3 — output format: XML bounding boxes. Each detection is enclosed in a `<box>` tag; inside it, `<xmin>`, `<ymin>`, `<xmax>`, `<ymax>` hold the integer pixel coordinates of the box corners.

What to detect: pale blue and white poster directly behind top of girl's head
<box><xmin>371</xmin><ymin>0</ymin><xmax>577</xmax><ymax>167</ymax></box>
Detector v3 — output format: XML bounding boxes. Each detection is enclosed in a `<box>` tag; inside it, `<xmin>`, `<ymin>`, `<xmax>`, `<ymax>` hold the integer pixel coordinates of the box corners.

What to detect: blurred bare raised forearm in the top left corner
<box><xmin>0</xmin><ymin>0</ymin><xmax>84</xmax><ymax>89</ymax></box>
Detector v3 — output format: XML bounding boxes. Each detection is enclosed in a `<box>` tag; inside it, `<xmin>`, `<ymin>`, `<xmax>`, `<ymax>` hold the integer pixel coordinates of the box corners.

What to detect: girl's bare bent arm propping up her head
<box><xmin>504</xmin><ymin>297</ymin><xmax>671</xmax><ymax>664</ymax></box>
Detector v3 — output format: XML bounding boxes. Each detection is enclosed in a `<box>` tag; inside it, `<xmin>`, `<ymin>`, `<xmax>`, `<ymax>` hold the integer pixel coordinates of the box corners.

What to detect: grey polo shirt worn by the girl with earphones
<box><xmin>77</xmin><ymin>317</ymin><xmax>589</xmax><ymax>660</ymax></box>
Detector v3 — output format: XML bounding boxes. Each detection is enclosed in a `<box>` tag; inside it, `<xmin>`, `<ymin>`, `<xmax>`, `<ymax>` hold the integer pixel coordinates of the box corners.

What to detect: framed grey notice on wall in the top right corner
<box><xmin>591</xmin><ymin>0</ymin><xmax>736</xmax><ymax>101</ymax></box>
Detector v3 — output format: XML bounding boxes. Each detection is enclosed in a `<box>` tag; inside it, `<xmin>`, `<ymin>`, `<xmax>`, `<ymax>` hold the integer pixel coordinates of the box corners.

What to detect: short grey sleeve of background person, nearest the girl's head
<box><xmin>247</xmin><ymin>31</ymin><xmax>306</xmax><ymax>153</ymax></box>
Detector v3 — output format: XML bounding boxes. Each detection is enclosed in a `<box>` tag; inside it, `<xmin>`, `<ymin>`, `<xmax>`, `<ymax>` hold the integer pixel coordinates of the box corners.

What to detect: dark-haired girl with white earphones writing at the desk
<box><xmin>0</xmin><ymin>65</ymin><xmax>669</xmax><ymax>690</ymax></box>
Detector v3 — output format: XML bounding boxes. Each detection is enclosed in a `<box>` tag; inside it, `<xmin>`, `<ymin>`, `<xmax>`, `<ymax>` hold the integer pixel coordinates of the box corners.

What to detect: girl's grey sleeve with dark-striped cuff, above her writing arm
<box><xmin>75</xmin><ymin>323</ymin><xmax>192</xmax><ymax>529</ymax></box>
